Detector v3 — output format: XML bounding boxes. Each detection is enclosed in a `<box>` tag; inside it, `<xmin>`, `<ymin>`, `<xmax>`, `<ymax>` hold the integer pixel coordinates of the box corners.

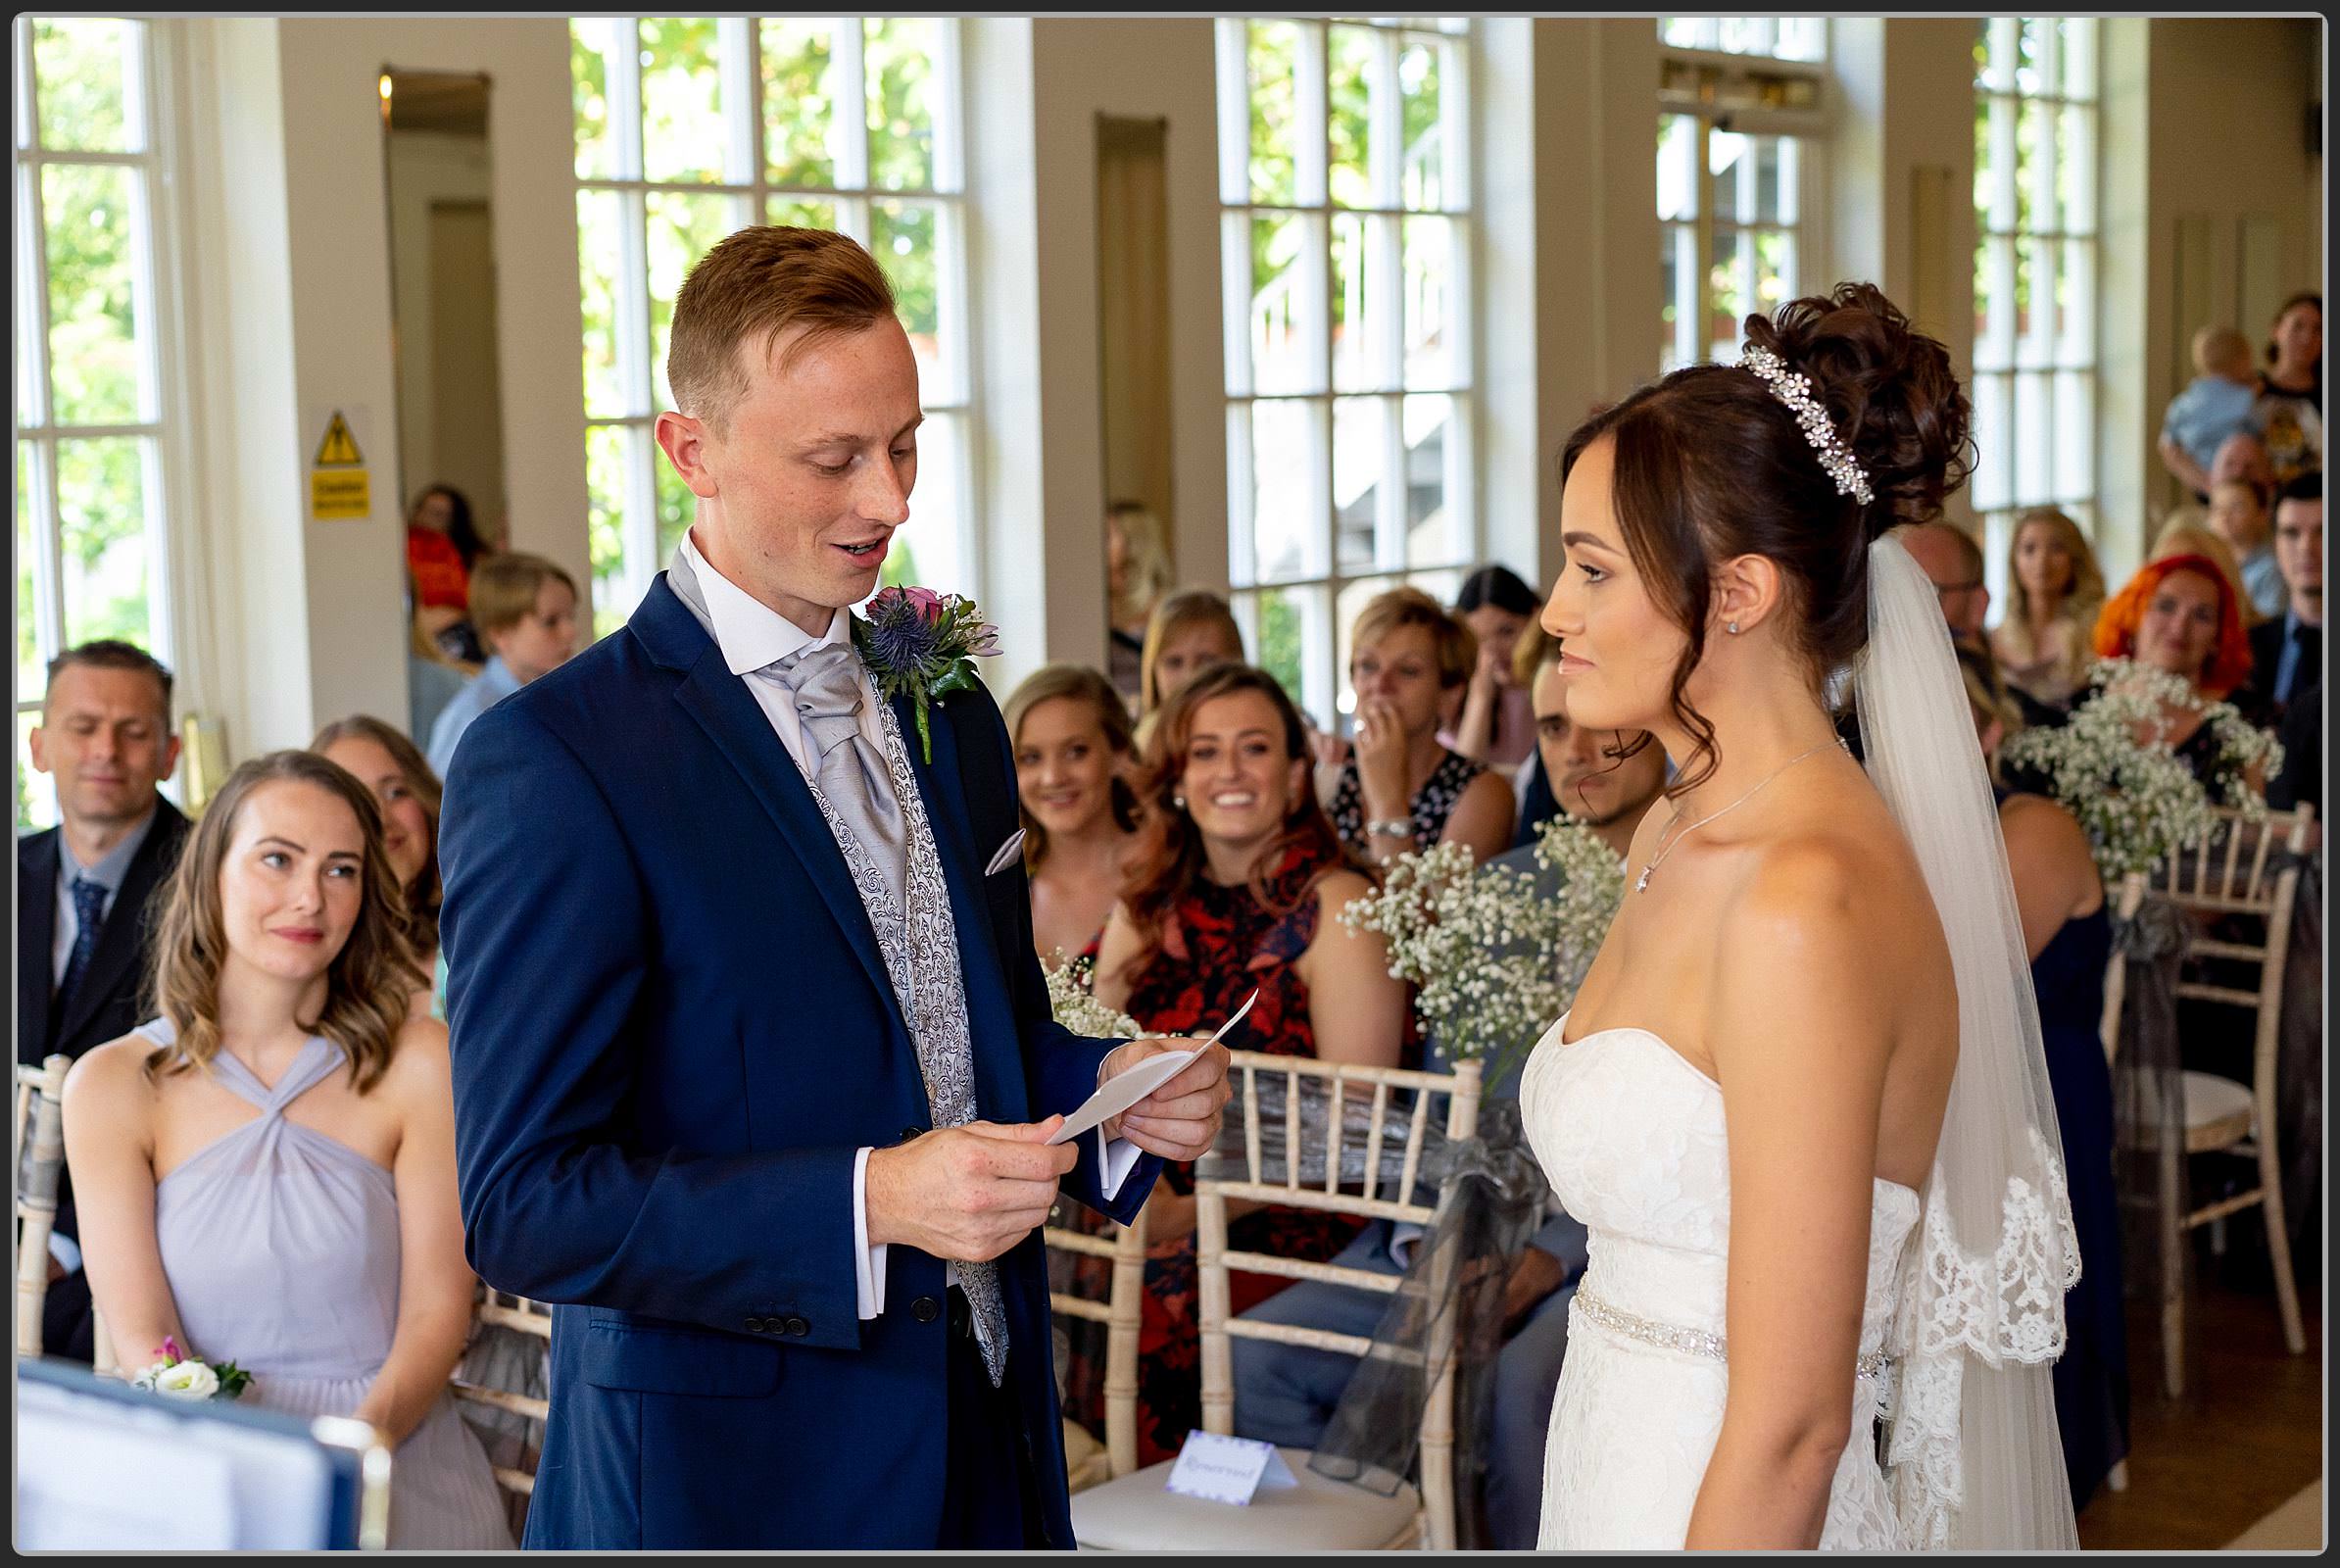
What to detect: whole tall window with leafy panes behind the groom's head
<box><xmin>568</xmin><ymin>17</ymin><xmax>981</xmax><ymax>634</ymax></box>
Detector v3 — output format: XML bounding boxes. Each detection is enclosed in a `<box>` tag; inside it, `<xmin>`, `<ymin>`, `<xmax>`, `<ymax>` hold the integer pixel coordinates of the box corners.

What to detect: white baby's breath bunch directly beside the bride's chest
<box><xmin>1341</xmin><ymin>816</ymin><xmax>1624</xmax><ymax>1081</ymax></box>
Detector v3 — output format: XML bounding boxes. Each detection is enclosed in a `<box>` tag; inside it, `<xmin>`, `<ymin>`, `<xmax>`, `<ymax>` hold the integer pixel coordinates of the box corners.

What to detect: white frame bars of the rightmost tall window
<box><xmin>1968</xmin><ymin>17</ymin><xmax>2104</xmax><ymax>602</ymax></box>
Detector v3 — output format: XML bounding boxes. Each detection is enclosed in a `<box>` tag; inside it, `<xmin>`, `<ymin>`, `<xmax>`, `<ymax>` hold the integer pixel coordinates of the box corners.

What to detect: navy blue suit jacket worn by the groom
<box><xmin>440</xmin><ymin>575</ymin><xmax>1160</xmax><ymax>1549</ymax></box>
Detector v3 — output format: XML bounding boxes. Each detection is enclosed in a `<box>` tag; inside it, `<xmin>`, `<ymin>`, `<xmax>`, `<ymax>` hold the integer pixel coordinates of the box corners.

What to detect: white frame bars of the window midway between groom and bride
<box><xmin>1217</xmin><ymin>17</ymin><xmax>1486</xmax><ymax>728</ymax></box>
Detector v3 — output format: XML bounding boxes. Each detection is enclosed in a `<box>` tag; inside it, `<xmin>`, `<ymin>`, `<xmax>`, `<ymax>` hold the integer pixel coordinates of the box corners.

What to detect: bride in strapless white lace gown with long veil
<box><xmin>1521</xmin><ymin>283</ymin><xmax>2078</xmax><ymax>1549</ymax></box>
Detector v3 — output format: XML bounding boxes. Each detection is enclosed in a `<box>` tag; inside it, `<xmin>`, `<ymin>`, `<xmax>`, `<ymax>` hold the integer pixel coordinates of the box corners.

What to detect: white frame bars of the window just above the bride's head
<box><xmin>1657</xmin><ymin>29</ymin><xmax>1829</xmax><ymax>369</ymax></box>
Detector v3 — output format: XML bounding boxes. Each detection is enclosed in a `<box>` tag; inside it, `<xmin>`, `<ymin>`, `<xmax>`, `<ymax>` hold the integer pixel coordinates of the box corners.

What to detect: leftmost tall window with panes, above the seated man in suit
<box><xmin>12</xmin><ymin>17</ymin><xmax>173</xmax><ymax>826</ymax></box>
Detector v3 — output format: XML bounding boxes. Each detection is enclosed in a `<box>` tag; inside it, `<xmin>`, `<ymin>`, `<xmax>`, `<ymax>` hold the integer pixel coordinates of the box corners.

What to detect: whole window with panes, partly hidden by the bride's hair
<box><xmin>1657</xmin><ymin>17</ymin><xmax>1828</xmax><ymax>369</ymax></box>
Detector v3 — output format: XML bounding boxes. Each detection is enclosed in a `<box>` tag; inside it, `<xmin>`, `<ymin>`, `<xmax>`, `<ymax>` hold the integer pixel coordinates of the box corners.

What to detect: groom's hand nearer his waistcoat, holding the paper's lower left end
<box><xmin>861</xmin><ymin>1116</ymin><xmax>1081</xmax><ymax>1264</ymax></box>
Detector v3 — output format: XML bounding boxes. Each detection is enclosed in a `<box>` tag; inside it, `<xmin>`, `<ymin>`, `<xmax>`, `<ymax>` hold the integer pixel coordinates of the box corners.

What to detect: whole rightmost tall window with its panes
<box><xmin>1973</xmin><ymin>17</ymin><xmax>2097</xmax><ymax>595</ymax></box>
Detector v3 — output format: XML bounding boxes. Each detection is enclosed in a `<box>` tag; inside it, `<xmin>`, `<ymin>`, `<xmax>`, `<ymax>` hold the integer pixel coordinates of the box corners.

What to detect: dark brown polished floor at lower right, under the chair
<box><xmin>2080</xmin><ymin>1275</ymin><xmax>2323</xmax><ymax>1551</ymax></box>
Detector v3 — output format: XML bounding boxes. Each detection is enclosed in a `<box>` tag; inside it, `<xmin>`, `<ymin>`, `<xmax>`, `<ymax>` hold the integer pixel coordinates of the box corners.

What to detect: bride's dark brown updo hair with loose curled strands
<box><xmin>1561</xmin><ymin>283</ymin><xmax>1973</xmax><ymax>796</ymax></box>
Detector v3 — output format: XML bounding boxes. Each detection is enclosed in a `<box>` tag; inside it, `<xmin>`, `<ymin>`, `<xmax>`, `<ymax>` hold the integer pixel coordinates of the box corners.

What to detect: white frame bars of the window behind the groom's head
<box><xmin>571</xmin><ymin>14</ymin><xmax>983</xmax><ymax>625</ymax></box>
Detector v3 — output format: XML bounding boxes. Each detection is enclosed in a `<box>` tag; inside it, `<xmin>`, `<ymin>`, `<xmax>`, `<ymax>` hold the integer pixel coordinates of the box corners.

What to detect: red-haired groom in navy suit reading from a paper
<box><xmin>440</xmin><ymin>227</ymin><xmax>1229</xmax><ymax>1549</ymax></box>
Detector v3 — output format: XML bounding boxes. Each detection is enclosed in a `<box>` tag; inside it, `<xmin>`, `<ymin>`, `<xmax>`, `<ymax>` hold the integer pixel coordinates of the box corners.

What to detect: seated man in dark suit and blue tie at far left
<box><xmin>17</xmin><ymin>639</ymin><xmax>187</xmax><ymax>1362</ymax></box>
